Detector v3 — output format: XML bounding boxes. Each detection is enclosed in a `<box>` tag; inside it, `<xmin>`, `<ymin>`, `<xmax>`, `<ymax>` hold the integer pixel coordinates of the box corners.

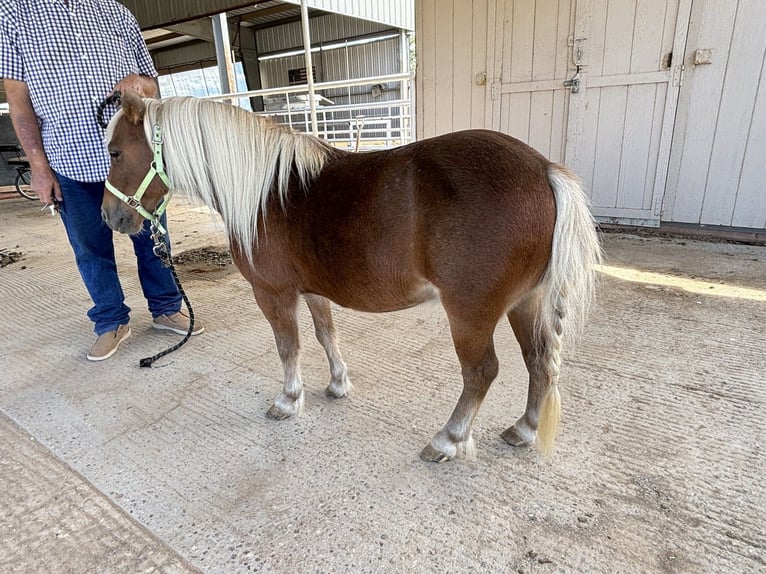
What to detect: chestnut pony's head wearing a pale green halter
<box><xmin>101</xmin><ymin>91</ymin><xmax>169</xmax><ymax>233</ymax></box>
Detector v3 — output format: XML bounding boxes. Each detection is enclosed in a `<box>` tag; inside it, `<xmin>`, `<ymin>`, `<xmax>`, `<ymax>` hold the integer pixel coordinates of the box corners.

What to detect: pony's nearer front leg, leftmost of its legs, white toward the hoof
<box><xmin>253</xmin><ymin>288</ymin><xmax>303</xmax><ymax>420</ymax></box>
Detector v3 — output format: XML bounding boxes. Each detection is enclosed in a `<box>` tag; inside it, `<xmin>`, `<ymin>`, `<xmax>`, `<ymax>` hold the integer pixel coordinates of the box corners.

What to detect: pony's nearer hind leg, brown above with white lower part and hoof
<box><xmin>420</xmin><ymin>318</ymin><xmax>498</xmax><ymax>462</ymax></box>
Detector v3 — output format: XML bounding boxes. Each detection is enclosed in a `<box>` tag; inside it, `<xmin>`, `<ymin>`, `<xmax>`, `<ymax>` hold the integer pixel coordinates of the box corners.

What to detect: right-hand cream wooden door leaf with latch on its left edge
<box><xmin>566</xmin><ymin>0</ymin><xmax>691</xmax><ymax>225</ymax></box>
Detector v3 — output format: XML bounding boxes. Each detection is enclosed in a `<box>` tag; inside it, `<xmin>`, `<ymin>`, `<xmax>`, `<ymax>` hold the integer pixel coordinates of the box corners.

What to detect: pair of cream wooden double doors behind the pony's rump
<box><xmin>488</xmin><ymin>0</ymin><xmax>691</xmax><ymax>225</ymax></box>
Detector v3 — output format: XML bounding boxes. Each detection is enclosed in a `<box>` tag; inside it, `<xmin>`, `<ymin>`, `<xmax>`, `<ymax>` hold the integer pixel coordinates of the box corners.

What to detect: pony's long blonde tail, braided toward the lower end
<box><xmin>537</xmin><ymin>164</ymin><xmax>601</xmax><ymax>456</ymax></box>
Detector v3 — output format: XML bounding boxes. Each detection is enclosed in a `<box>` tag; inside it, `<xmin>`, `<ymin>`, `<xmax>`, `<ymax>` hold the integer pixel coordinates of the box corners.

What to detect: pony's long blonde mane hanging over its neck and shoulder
<box><xmin>144</xmin><ymin>97</ymin><xmax>331</xmax><ymax>258</ymax></box>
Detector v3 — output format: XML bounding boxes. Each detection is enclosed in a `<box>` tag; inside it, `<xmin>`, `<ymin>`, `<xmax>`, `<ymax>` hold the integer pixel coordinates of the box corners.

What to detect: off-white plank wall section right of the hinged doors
<box><xmin>663</xmin><ymin>0</ymin><xmax>766</xmax><ymax>229</ymax></box>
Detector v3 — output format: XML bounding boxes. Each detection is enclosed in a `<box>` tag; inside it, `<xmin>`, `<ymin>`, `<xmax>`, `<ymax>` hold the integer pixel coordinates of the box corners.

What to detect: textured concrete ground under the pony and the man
<box><xmin>0</xmin><ymin>198</ymin><xmax>766</xmax><ymax>573</ymax></box>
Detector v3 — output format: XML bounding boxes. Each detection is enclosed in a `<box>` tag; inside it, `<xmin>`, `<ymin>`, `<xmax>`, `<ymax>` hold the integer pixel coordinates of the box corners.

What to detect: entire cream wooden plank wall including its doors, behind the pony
<box><xmin>416</xmin><ymin>0</ymin><xmax>766</xmax><ymax>232</ymax></box>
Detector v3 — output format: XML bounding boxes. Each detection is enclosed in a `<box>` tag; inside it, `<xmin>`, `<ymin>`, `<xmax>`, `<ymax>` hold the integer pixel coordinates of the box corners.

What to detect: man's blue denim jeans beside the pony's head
<box><xmin>56</xmin><ymin>173</ymin><xmax>181</xmax><ymax>335</ymax></box>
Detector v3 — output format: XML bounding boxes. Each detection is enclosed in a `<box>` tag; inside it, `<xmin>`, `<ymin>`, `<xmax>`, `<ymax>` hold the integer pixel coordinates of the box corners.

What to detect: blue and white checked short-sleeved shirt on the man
<box><xmin>0</xmin><ymin>0</ymin><xmax>157</xmax><ymax>182</ymax></box>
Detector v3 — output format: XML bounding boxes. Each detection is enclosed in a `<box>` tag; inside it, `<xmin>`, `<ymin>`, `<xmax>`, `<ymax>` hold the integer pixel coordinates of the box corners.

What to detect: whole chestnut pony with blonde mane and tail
<box><xmin>102</xmin><ymin>93</ymin><xmax>601</xmax><ymax>461</ymax></box>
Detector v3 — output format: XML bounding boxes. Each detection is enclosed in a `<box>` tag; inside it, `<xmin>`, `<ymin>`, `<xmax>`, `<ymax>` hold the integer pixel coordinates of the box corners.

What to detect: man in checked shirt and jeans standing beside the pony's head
<box><xmin>0</xmin><ymin>0</ymin><xmax>204</xmax><ymax>361</ymax></box>
